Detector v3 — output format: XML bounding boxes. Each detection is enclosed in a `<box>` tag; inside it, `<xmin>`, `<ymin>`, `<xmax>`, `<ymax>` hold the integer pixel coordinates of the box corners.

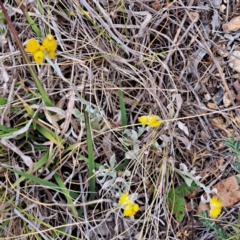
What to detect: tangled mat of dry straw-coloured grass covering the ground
<box><xmin>0</xmin><ymin>0</ymin><xmax>239</xmax><ymax>240</ymax></box>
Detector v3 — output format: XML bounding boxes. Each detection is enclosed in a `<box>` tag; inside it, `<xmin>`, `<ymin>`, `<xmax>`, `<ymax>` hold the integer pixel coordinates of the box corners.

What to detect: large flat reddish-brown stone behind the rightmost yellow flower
<box><xmin>198</xmin><ymin>174</ymin><xmax>240</xmax><ymax>213</ymax></box>
